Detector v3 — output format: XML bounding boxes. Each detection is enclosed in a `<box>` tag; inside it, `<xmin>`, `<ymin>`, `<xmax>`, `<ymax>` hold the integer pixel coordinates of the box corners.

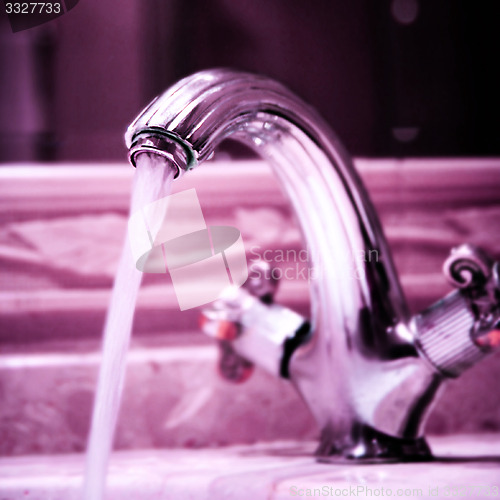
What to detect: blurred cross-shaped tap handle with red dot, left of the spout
<box><xmin>200</xmin><ymin>261</ymin><xmax>310</xmax><ymax>382</ymax></box>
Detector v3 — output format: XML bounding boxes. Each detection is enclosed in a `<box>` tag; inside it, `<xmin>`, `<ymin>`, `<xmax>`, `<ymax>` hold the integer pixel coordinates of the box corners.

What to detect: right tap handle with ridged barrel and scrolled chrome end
<box><xmin>414</xmin><ymin>245</ymin><xmax>500</xmax><ymax>377</ymax></box>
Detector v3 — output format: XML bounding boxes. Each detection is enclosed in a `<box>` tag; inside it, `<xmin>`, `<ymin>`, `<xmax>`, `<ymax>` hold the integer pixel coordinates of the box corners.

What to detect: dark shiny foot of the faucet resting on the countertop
<box><xmin>315</xmin><ymin>424</ymin><xmax>433</xmax><ymax>464</ymax></box>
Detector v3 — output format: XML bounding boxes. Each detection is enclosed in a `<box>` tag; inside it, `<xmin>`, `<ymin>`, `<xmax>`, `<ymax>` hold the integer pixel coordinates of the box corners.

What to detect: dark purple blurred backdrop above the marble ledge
<box><xmin>0</xmin><ymin>0</ymin><xmax>500</xmax><ymax>162</ymax></box>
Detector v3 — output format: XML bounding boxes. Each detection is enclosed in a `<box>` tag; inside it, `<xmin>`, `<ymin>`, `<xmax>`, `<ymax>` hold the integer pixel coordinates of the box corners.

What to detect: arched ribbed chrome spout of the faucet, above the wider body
<box><xmin>126</xmin><ymin>69</ymin><xmax>409</xmax><ymax>331</ymax></box>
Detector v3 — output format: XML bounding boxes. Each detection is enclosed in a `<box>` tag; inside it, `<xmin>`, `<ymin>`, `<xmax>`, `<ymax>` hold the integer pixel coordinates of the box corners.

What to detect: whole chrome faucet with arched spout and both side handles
<box><xmin>126</xmin><ymin>69</ymin><xmax>500</xmax><ymax>463</ymax></box>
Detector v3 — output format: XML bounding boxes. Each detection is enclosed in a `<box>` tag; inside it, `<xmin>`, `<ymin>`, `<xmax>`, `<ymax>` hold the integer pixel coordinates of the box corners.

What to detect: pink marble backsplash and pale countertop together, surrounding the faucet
<box><xmin>0</xmin><ymin>159</ymin><xmax>500</xmax><ymax>500</ymax></box>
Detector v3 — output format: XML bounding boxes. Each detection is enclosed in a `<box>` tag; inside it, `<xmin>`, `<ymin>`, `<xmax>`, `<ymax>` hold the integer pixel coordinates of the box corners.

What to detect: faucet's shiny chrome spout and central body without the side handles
<box><xmin>126</xmin><ymin>70</ymin><xmax>498</xmax><ymax>461</ymax></box>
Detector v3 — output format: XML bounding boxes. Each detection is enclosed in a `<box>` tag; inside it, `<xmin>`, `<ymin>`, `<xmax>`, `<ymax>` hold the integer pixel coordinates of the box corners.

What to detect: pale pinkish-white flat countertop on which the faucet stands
<box><xmin>0</xmin><ymin>434</ymin><xmax>500</xmax><ymax>500</ymax></box>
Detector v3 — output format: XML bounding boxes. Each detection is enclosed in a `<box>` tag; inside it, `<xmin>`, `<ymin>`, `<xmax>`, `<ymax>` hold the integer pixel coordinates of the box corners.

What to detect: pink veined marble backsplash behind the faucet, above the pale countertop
<box><xmin>0</xmin><ymin>158</ymin><xmax>500</xmax><ymax>454</ymax></box>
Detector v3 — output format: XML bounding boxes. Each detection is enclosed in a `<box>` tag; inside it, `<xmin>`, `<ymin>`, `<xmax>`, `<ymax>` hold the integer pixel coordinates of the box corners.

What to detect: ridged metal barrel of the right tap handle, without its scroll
<box><xmin>415</xmin><ymin>291</ymin><xmax>486</xmax><ymax>377</ymax></box>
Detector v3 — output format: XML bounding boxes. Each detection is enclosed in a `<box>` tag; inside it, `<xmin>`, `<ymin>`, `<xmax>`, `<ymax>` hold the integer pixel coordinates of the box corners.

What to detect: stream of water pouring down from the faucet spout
<box><xmin>83</xmin><ymin>153</ymin><xmax>174</xmax><ymax>500</ymax></box>
